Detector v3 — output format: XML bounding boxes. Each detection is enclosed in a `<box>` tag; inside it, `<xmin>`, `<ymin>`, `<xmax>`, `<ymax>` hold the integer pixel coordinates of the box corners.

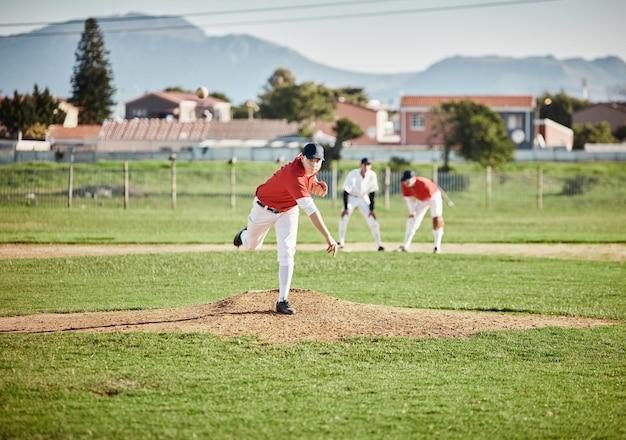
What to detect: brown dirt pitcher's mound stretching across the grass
<box><xmin>0</xmin><ymin>289</ymin><xmax>615</xmax><ymax>342</ymax></box>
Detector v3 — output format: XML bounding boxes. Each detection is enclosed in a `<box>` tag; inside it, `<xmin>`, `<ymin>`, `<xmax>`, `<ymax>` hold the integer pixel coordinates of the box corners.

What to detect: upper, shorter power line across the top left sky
<box><xmin>0</xmin><ymin>0</ymin><xmax>409</xmax><ymax>27</ymax></box>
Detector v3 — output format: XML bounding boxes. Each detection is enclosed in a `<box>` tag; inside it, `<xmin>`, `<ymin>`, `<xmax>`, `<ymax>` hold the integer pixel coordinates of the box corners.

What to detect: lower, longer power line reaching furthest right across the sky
<box><xmin>0</xmin><ymin>0</ymin><xmax>562</xmax><ymax>38</ymax></box>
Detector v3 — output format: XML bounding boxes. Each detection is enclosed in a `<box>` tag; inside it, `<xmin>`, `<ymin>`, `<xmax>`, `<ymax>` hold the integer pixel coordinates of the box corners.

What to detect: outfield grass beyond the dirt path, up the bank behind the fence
<box><xmin>0</xmin><ymin>162</ymin><xmax>626</xmax><ymax>243</ymax></box>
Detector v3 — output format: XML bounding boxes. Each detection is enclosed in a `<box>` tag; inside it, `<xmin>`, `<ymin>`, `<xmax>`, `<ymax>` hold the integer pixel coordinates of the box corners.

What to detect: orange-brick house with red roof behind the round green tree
<box><xmin>400</xmin><ymin>95</ymin><xmax>535</xmax><ymax>149</ymax></box>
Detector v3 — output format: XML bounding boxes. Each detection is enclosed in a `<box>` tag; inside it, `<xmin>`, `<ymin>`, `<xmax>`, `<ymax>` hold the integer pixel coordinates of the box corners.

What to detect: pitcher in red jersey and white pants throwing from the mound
<box><xmin>233</xmin><ymin>143</ymin><xmax>337</xmax><ymax>315</ymax></box>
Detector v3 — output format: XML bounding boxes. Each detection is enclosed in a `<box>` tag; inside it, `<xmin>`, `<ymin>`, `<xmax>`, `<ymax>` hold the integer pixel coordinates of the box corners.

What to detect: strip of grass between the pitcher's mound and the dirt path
<box><xmin>0</xmin><ymin>251</ymin><xmax>626</xmax><ymax>319</ymax></box>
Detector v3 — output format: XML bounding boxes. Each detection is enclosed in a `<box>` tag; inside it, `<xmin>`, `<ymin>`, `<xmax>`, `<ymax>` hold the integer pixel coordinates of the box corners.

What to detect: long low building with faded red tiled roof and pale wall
<box><xmin>98</xmin><ymin>118</ymin><xmax>298</xmax><ymax>152</ymax></box>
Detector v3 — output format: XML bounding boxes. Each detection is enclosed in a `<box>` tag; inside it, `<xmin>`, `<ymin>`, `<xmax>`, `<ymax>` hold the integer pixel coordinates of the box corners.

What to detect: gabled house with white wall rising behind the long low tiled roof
<box><xmin>125</xmin><ymin>92</ymin><xmax>231</xmax><ymax>122</ymax></box>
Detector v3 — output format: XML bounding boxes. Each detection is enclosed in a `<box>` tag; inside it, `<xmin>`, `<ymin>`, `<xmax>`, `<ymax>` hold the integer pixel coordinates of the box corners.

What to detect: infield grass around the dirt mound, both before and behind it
<box><xmin>0</xmin><ymin>252</ymin><xmax>626</xmax><ymax>438</ymax></box>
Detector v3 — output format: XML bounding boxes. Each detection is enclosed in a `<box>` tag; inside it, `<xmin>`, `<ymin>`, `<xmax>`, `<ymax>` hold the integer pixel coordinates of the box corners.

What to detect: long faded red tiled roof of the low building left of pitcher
<box><xmin>100</xmin><ymin>119</ymin><xmax>298</xmax><ymax>141</ymax></box>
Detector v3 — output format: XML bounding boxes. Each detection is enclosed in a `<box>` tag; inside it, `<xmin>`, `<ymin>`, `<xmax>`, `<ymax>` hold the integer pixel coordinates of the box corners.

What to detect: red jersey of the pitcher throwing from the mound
<box><xmin>256</xmin><ymin>155</ymin><xmax>315</xmax><ymax>212</ymax></box>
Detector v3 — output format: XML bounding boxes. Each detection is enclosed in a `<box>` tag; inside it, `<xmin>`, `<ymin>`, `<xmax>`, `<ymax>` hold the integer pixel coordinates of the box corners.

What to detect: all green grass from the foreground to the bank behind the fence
<box><xmin>0</xmin><ymin>163</ymin><xmax>626</xmax><ymax>439</ymax></box>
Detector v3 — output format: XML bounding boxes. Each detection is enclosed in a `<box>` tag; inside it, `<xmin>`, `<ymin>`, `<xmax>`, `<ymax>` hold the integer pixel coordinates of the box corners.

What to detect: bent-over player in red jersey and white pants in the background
<box><xmin>398</xmin><ymin>170</ymin><xmax>443</xmax><ymax>254</ymax></box>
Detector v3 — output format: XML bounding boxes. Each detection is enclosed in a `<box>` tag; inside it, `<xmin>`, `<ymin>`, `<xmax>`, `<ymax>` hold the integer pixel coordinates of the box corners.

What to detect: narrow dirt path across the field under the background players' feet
<box><xmin>0</xmin><ymin>243</ymin><xmax>626</xmax><ymax>262</ymax></box>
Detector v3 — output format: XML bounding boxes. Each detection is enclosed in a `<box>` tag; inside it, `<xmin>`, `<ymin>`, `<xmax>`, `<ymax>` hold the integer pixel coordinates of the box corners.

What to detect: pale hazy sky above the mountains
<box><xmin>0</xmin><ymin>0</ymin><xmax>626</xmax><ymax>73</ymax></box>
